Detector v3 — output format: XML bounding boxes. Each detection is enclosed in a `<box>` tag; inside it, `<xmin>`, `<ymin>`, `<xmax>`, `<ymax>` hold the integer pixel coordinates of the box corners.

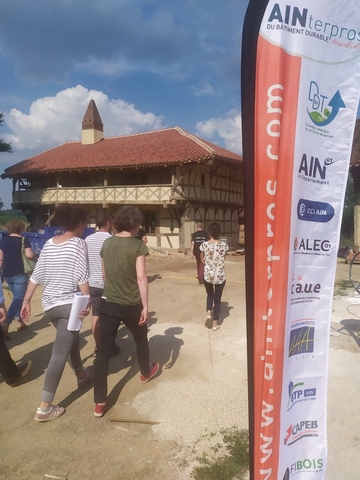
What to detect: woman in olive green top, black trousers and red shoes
<box><xmin>94</xmin><ymin>206</ymin><xmax>159</xmax><ymax>417</ymax></box>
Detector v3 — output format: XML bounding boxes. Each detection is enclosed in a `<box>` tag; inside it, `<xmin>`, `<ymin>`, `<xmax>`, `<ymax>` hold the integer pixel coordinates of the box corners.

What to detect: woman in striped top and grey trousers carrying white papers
<box><xmin>21</xmin><ymin>204</ymin><xmax>94</xmax><ymax>422</ymax></box>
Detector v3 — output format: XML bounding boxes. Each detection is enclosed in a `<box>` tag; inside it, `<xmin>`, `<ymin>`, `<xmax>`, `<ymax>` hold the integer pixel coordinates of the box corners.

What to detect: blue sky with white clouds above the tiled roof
<box><xmin>0</xmin><ymin>0</ymin><xmax>248</xmax><ymax>209</ymax></box>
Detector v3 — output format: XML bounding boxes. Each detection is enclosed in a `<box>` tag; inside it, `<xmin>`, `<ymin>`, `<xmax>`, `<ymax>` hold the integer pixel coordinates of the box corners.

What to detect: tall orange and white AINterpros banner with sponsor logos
<box><xmin>242</xmin><ymin>0</ymin><xmax>360</xmax><ymax>480</ymax></box>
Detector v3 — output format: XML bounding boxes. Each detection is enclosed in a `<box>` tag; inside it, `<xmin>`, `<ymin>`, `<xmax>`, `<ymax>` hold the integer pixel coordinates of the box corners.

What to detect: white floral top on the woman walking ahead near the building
<box><xmin>200</xmin><ymin>241</ymin><xmax>229</xmax><ymax>284</ymax></box>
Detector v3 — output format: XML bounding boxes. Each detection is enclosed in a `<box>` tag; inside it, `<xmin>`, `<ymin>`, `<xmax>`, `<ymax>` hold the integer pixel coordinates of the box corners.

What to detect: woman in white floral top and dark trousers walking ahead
<box><xmin>200</xmin><ymin>222</ymin><xmax>229</xmax><ymax>331</ymax></box>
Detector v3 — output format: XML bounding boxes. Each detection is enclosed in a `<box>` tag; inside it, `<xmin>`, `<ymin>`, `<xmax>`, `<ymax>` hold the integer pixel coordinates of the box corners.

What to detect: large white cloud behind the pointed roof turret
<box><xmin>4</xmin><ymin>85</ymin><xmax>163</xmax><ymax>153</ymax></box>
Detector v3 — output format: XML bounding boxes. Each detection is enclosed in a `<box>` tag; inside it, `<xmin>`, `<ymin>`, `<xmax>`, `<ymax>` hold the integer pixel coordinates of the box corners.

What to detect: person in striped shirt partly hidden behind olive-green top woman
<box><xmin>85</xmin><ymin>213</ymin><xmax>120</xmax><ymax>357</ymax></box>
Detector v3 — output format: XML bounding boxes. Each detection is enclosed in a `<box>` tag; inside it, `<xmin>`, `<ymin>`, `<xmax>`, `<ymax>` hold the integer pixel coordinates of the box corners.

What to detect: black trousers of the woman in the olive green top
<box><xmin>94</xmin><ymin>299</ymin><xmax>150</xmax><ymax>403</ymax></box>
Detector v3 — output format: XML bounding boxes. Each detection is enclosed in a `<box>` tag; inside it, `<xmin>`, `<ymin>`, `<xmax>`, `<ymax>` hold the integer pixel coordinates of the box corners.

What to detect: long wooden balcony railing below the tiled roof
<box><xmin>13</xmin><ymin>184</ymin><xmax>181</xmax><ymax>208</ymax></box>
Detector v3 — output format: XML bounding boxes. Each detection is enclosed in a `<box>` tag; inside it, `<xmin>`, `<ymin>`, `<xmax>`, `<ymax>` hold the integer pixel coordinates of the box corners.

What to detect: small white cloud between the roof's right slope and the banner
<box><xmin>196</xmin><ymin>110</ymin><xmax>242</xmax><ymax>155</ymax></box>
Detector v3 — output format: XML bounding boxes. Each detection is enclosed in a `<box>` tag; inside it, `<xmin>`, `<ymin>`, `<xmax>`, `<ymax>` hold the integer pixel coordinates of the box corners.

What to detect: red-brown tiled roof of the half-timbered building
<box><xmin>1</xmin><ymin>127</ymin><xmax>242</xmax><ymax>178</ymax></box>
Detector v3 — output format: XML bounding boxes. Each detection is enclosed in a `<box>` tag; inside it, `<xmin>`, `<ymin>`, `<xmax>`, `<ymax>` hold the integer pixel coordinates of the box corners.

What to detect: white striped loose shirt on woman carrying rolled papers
<box><xmin>30</xmin><ymin>237</ymin><xmax>89</xmax><ymax>311</ymax></box>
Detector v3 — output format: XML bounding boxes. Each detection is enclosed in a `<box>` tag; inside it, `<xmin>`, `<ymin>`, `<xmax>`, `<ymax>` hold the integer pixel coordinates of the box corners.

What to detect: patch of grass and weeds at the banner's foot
<box><xmin>192</xmin><ymin>427</ymin><xmax>249</xmax><ymax>480</ymax></box>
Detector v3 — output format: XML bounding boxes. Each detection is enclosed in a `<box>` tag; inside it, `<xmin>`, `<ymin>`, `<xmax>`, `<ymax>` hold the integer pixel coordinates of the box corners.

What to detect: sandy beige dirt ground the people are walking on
<box><xmin>0</xmin><ymin>254</ymin><xmax>360</xmax><ymax>480</ymax></box>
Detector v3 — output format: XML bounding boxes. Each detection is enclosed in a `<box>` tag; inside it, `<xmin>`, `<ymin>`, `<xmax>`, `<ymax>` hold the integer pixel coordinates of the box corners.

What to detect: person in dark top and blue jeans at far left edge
<box><xmin>0</xmin><ymin>220</ymin><xmax>36</xmax><ymax>340</ymax></box>
